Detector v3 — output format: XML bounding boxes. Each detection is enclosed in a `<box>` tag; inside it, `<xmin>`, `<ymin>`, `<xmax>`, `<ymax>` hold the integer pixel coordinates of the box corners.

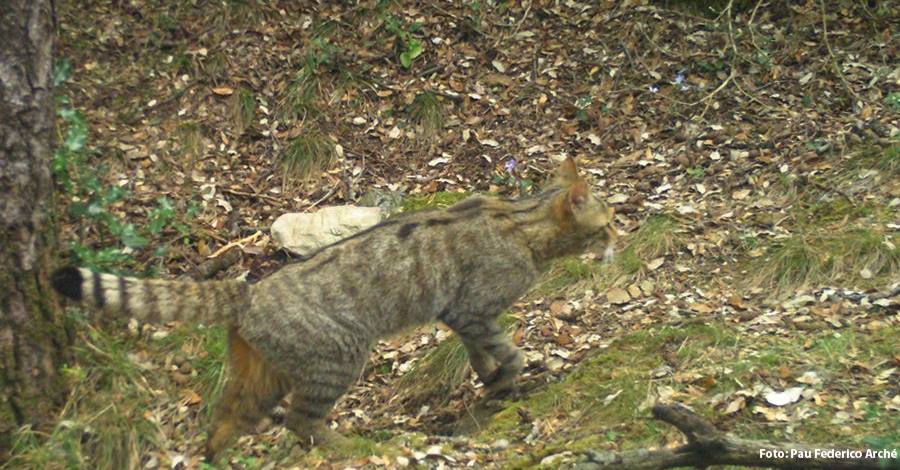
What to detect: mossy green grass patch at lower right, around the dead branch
<box><xmin>471</xmin><ymin>323</ymin><xmax>900</xmax><ymax>468</ymax></box>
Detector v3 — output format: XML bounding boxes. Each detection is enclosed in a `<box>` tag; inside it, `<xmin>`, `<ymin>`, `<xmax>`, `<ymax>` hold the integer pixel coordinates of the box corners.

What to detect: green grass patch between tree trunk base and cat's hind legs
<box><xmin>0</xmin><ymin>325</ymin><xmax>225</xmax><ymax>470</ymax></box>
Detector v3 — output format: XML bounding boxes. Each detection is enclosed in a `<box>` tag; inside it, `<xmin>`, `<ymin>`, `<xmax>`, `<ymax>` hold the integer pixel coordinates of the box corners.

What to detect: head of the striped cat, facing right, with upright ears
<box><xmin>554</xmin><ymin>158</ymin><xmax>619</xmax><ymax>261</ymax></box>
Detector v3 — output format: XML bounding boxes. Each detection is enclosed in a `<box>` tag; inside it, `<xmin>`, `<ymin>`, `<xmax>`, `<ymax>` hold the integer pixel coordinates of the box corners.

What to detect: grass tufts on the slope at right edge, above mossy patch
<box><xmin>736</xmin><ymin>144</ymin><xmax>900</xmax><ymax>297</ymax></box>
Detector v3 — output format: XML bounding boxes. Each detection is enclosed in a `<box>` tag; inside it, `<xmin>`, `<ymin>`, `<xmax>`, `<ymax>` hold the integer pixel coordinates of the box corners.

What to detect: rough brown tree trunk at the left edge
<box><xmin>0</xmin><ymin>0</ymin><xmax>71</xmax><ymax>464</ymax></box>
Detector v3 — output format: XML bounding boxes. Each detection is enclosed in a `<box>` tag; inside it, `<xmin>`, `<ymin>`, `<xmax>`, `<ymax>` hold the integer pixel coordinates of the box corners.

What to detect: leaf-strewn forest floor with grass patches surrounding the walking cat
<box><xmin>10</xmin><ymin>0</ymin><xmax>900</xmax><ymax>469</ymax></box>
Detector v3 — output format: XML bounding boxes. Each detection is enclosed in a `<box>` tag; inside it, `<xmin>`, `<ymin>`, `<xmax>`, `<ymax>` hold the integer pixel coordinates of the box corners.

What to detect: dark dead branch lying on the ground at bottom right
<box><xmin>566</xmin><ymin>405</ymin><xmax>900</xmax><ymax>470</ymax></box>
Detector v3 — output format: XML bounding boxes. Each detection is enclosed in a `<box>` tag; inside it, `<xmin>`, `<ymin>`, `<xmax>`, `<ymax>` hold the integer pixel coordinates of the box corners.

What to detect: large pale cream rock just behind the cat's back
<box><xmin>271</xmin><ymin>206</ymin><xmax>384</xmax><ymax>256</ymax></box>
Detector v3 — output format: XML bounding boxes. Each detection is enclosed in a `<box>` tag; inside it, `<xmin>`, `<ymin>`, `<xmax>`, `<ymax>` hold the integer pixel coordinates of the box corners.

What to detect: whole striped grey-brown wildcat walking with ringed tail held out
<box><xmin>53</xmin><ymin>159</ymin><xmax>616</xmax><ymax>462</ymax></box>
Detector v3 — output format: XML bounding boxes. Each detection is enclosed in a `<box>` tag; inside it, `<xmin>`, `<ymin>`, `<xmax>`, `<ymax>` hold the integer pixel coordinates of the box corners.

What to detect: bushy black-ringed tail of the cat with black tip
<box><xmin>51</xmin><ymin>267</ymin><xmax>250</xmax><ymax>324</ymax></box>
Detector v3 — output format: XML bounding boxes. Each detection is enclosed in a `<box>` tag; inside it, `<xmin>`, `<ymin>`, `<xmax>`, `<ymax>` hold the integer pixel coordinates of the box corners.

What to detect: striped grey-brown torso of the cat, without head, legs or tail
<box><xmin>244</xmin><ymin>197</ymin><xmax>535</xmax><ymax>336</ymax></box>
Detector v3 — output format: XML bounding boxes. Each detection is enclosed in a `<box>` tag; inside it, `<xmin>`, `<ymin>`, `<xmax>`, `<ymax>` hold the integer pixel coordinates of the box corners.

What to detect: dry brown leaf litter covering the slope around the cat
<box><xmin>54</xmin><ymin>0</ymin><xmax>900</xmax><ymax>468</ymax></box>
